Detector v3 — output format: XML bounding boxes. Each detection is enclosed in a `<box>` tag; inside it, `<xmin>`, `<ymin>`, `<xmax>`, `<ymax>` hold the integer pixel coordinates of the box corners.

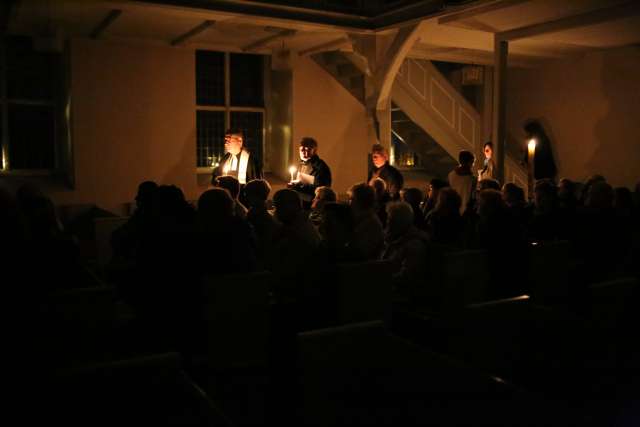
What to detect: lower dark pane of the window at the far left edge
<box><xmin>8</xmin><ymin>104</ymin><xmax>55</xmax><ymax>169</ymax></box>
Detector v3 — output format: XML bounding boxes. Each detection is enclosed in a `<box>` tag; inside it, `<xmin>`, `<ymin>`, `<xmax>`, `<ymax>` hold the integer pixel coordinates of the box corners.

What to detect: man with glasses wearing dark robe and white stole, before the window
<box><xmin>211</xmin><ymin>128</ymin><xmax>262</xmax><ymax>186</ymax></box>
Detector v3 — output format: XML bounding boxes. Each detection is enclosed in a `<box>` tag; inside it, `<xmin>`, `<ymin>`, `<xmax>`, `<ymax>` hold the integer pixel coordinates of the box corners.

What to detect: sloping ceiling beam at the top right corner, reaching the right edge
<box><xmin>498</xmin><ymin>0</ymin><xmax>640</xmax><ymax>41</ymax></box>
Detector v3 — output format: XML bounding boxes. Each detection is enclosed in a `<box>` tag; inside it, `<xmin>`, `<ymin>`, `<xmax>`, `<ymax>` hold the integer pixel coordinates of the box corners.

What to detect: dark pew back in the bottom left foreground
<box><xmin>47</xmin><ymin>353</ymin><xmax>231</xmax><ymax>426</ymax></box>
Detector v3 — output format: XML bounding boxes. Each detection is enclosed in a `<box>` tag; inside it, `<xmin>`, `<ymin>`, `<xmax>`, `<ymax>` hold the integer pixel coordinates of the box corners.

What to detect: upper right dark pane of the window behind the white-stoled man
<box><xmin>229</xmin><ymin>53</ymin><xmax>264</xmax><ymax>107</ymax></box>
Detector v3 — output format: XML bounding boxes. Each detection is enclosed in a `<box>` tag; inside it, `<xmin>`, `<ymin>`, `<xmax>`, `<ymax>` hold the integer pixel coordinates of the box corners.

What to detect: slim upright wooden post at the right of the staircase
<box><xmin>492</xmin><ymin>35</ymin><xmax>509</xmax><ymax>184</ymax></box>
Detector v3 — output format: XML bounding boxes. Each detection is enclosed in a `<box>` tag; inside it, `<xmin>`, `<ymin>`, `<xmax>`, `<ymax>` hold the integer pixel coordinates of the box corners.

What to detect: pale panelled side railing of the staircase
<box><xmin>392</xmin><ymin>58</ymin><xmax>527</xmax><ymax>189</ymax></box>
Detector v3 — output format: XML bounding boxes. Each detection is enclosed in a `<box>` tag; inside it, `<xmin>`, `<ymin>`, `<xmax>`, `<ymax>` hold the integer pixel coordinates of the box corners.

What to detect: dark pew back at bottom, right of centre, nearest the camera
<box><xmin>294</xmin><ymin>322</ymin><xmax>562</xmax><ymax>426</ymax></box>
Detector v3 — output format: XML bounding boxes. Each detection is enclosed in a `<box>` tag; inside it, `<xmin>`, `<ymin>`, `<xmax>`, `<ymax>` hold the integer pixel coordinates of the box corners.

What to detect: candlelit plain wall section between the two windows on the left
<box><xmin>52</xmin><ymin>40</ymin><xmax>200</xmax><ymax>213</ymax></box>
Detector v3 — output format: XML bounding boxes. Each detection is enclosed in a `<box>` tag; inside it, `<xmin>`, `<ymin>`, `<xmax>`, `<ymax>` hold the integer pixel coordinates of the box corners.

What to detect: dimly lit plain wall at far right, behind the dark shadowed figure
<box><xmin>507</xmin><ymin>47</ymin><xmax>640</xmax><ymax>187</ymax></box>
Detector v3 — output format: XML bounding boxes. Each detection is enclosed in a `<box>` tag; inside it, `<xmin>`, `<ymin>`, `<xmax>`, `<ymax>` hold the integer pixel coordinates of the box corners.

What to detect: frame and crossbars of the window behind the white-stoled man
<box><xmin>194</xmin><ymin>49</ymin><xmax>268</xmax><ymax>174</ymax></box>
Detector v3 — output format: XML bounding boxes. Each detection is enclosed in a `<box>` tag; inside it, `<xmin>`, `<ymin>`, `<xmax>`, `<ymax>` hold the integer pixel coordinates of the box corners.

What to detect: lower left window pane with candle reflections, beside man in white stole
<box><xmin>196</xmin><ymin>110</ymin><xmax>225</xmax><ymax>168</ymax></box>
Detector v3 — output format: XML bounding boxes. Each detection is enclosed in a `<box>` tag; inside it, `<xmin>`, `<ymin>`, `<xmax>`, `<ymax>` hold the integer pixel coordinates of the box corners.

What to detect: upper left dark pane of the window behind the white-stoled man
<box><xmin>196</xmin><ymin>50</ymin><xmax>224</xmax><ymax>105</ymax></box>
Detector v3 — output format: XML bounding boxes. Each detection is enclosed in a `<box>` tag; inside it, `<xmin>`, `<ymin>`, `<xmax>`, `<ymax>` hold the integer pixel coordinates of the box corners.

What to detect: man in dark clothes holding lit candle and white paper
<box><xmin>288</xmin><ymin>137</ymin><xmax>331</xmax><ymax>209</ymax></box>
